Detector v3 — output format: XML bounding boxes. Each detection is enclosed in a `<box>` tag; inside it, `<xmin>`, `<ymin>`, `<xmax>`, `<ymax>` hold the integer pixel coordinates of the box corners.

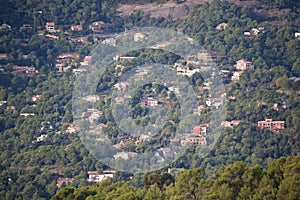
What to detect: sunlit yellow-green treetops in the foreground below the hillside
<box><xmin>52</xmin><ymin>157</ymin><xmax>300</xmax><ymax>200</ymax></box>
